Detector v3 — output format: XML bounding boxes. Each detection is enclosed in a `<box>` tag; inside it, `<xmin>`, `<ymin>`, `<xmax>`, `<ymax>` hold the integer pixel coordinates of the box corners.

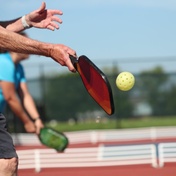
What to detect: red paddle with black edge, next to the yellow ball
<box><xmin>70</xmin><ymin>56</ymin><xmax>114</xmax><ymax>115</ymax></box>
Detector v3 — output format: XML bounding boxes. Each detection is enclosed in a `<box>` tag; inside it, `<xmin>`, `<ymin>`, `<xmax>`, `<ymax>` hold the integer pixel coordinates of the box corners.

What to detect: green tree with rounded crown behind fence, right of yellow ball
<box><xmin>138</xmin><ymin>66</ymin><xmax>168</xmax><ymax>115</ymax></box>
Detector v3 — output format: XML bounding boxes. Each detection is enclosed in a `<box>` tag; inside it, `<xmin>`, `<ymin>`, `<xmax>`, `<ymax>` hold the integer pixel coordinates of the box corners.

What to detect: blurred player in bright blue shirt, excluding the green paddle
<box><xmin>0</xmin><ymin>33</ymin><xmax>43</xmax><ymax>134</ymax></box>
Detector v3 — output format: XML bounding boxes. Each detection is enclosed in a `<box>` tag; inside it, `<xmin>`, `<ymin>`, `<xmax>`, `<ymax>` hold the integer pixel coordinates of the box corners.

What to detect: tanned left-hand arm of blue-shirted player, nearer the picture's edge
<box><xmin>1</xmin><ymin>81</ymin><xmax>36</xmax><ymax>133</ymax></box>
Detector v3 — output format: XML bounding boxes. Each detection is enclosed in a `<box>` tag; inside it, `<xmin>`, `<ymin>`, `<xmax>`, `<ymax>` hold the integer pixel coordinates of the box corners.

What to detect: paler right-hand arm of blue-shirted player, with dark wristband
<box><xmin>18</xmin><ymin>82</ymin><xmax>44</xmax><ymax>134</ymax></box>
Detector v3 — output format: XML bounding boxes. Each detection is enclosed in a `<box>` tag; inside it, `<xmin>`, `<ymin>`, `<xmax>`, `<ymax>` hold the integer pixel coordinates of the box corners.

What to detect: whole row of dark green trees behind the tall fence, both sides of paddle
<box><xmin>40</xmin><ymin>67</ymin><xmax>176</xmax><ymax>121</ymax></box>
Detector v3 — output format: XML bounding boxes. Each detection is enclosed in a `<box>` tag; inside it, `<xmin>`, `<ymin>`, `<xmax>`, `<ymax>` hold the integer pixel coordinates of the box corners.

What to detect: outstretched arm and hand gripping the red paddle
<box><xmin>0</xmin><ymin>26</ymin><xmax>77</xmax><ymax>72</ymax></box>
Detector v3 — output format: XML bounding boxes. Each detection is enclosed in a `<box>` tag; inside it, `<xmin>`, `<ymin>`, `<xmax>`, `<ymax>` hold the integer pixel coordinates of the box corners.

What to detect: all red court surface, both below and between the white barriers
<box><xmin>17</xmin><ymin>128</ymin><xmax>176</xmax><ymax>176</ymax></box>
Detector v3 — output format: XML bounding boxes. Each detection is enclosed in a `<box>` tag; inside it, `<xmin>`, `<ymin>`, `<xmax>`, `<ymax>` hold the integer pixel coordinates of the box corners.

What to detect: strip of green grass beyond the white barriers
<box><xmin>47</xmin><ymin>116</ymin><xmax>176</xmax><ymax>131</ymax></box>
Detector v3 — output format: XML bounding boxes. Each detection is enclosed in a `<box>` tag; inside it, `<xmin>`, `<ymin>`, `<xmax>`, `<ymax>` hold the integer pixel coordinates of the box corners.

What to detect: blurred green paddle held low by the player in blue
<box><xmin>39</xmin><ymin>127</ymin><xmax>68</xmax><ymax>152</ymax></box>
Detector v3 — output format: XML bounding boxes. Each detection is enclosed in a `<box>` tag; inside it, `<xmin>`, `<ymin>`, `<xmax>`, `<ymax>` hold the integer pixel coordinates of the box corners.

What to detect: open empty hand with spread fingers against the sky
<box><xmin>26</xmin><ymin>2</ymin><xmax>63</xmax><ymax>31</ymax></box>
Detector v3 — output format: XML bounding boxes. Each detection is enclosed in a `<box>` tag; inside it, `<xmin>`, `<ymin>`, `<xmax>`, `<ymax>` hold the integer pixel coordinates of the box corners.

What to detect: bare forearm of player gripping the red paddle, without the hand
<box><xmin>0</xmin><ymin>26</ymin><xmax>52</xmax><ymax>56</ymax></box>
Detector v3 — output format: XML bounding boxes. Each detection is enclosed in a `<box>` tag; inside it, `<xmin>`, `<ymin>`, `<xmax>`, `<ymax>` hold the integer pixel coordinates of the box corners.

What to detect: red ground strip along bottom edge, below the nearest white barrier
<box><xmin>19</xmin><ymin>164</ymin><xmax>176</xmax><ymax>176</ymax></box>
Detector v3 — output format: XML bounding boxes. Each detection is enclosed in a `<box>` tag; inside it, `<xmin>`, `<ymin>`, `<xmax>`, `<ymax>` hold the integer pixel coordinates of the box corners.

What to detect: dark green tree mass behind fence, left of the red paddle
<box><xmin>45</xmin><ymin>74</ymin><xmax>100</xmax><ymax>121</ymax></box>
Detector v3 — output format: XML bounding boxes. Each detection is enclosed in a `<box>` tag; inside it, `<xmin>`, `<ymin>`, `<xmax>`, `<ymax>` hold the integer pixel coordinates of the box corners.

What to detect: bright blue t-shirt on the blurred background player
<box><xmin>0</xmin><ymin>53</ymin><xmax>26</xmax><ymax>112</ymax></box>
